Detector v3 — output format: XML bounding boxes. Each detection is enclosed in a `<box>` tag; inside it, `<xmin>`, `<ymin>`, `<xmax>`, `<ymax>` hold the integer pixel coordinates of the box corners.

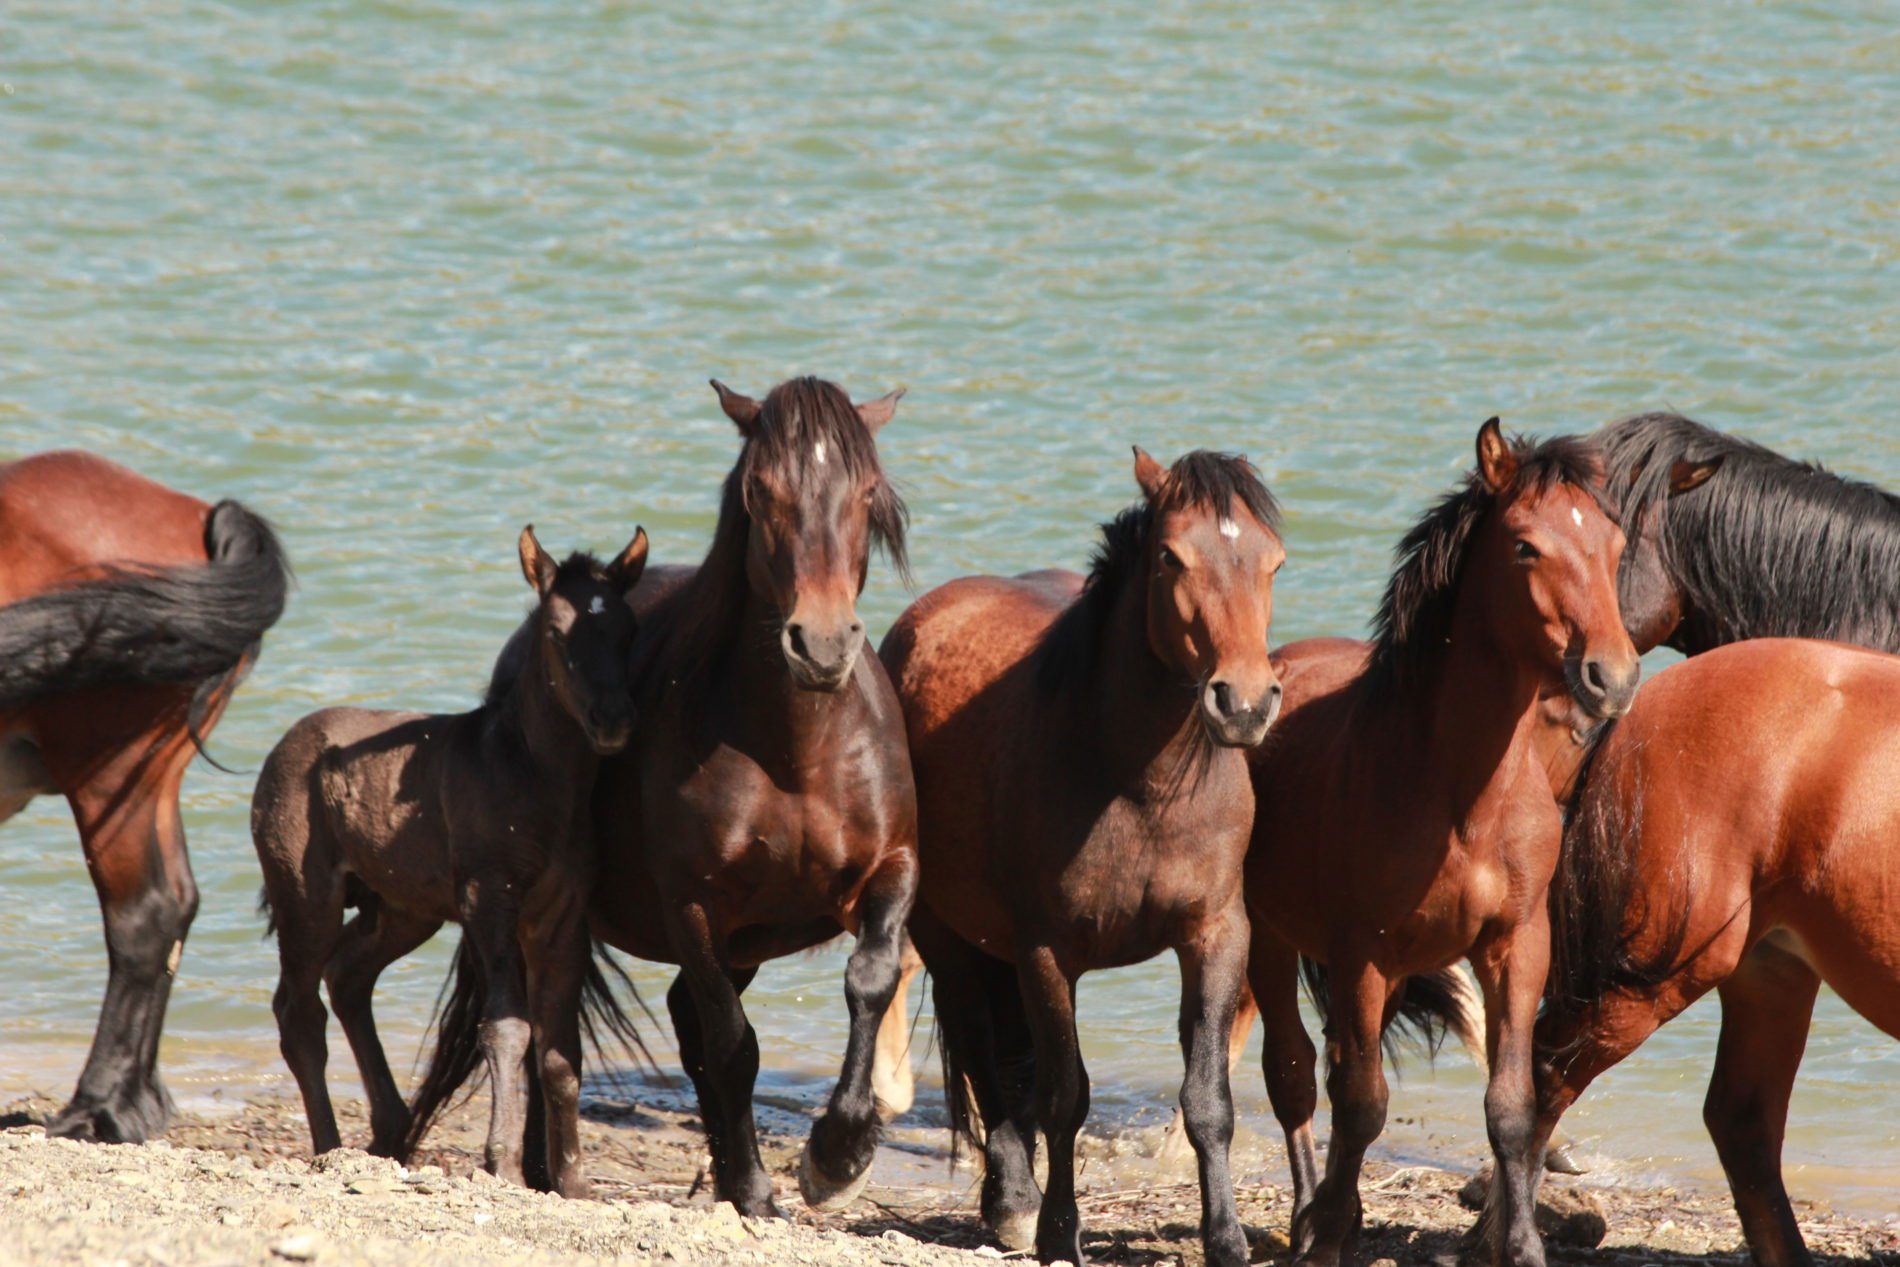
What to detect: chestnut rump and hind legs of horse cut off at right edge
<box><xmin>1537</xmin><ymin>638</ymin><xmax>1900</xmax><ymax>1267</ymax></box>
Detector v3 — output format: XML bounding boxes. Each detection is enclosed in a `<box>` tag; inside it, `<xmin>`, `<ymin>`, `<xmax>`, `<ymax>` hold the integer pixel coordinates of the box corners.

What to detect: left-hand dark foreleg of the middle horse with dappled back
<box><xmin>1017</xmin><ymin>946</ymin><xmax>1089</xmax><ymax>1267</ymax></box>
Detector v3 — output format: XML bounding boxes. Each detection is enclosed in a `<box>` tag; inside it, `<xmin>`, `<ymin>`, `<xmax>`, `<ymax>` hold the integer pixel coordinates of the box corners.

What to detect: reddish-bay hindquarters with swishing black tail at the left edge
<box><xmin>0</xmin><ymin>452</ymin><xmax>291</xmax><ymax>1142</ymax></box>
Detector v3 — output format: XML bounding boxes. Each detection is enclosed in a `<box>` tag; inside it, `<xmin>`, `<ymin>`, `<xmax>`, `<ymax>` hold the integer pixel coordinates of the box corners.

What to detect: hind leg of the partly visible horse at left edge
<box><xmin>48</xmin><ymin>745</ymin><xmax>198</xmax><ymax>1144</ymax></box>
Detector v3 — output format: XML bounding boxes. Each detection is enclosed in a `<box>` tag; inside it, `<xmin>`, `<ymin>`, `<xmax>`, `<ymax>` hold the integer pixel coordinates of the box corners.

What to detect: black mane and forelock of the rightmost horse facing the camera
<box><xmin>1366</xmin><ymin>435</ymin><xmax>1615</xmax><ymax>695</ymax></box>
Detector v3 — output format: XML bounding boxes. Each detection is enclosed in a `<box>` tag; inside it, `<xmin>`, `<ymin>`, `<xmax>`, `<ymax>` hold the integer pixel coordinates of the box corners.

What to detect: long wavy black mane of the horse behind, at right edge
<box><xmin>1596</xmin><ymin>414</ymin><xmax>1900</xmax><ymax>652</ymax></box>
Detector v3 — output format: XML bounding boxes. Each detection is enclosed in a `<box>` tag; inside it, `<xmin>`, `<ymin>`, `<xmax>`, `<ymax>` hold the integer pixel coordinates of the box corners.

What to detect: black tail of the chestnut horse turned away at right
<box><xmin>1545</xmin><ymin>728</ymin><xmax>1689</xmax><ymax>1033</ymax></box>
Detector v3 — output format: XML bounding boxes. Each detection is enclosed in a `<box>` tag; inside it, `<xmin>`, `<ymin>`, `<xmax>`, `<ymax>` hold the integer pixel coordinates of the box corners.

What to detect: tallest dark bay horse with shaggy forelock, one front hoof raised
<box><xmin>418</xmin><ymin>378</ymin><xmax>918</xmax><ymax>1216</ymax></box>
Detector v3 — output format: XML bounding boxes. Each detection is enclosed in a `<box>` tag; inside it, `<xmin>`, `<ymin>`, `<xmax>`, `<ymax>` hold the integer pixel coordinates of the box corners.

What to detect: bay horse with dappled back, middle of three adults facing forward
<box><xmin>882</xmin><ymin>450</ymin><xmax>1286</xmax><ymax>1263</ymax></box>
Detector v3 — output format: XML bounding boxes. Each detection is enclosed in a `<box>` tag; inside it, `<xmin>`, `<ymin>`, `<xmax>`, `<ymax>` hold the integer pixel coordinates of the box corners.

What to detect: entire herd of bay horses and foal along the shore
<box><xmin>0</xmin><ymin>387</ymin><xmax>1900</xmax><ymax>1267</ymax></box>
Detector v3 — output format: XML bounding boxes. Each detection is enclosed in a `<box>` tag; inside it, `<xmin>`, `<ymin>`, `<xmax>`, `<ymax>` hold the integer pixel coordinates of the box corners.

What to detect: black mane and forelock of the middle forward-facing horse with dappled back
<box><xmin>1036</xmin><ymin>448</ymin><xmax>1281</xmax><ymax>695</ymax></box>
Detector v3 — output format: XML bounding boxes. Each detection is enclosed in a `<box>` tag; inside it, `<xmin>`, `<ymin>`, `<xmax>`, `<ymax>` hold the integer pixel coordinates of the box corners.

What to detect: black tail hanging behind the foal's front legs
<box><xmin>399</xmin><ymin>936</ymin><xmax>659</xmax><ymax>1161</ymax></box>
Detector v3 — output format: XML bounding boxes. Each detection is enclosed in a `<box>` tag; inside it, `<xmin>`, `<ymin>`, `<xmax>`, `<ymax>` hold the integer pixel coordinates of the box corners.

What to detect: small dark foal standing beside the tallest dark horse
<box><xmin>251</xmin><ymin>524</ymin><xmax>646</xmax><ymax>1197</ymax></box>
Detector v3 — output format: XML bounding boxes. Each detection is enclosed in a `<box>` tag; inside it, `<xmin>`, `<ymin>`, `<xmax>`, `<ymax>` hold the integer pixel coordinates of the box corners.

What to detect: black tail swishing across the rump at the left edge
<box><xmin>0</xmin><ymin>501</ymin><xmax>291</xmax><ymax>739</ymax></box>
